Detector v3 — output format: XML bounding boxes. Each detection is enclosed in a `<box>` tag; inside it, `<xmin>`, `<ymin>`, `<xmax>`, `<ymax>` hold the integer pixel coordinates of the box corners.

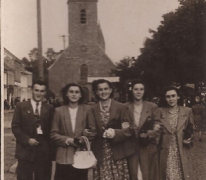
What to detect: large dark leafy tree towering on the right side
<box><xmin>137</xmin><ymin>0</ymin><xmax>206</xmax><ymax>87</ymax></box>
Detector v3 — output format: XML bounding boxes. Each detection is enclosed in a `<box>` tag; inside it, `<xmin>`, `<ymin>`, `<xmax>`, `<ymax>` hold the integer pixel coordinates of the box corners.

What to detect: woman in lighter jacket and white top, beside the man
<box><xmin>51</xmin><ymin>83</ymin><xmax>90</xmax><ymax>180</ymax></box>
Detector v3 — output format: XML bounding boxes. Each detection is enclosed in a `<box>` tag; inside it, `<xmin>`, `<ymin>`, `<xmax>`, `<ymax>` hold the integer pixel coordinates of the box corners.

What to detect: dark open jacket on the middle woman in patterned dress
<box><xmin>87</xmin><ymin>100</ymin><xmax>136</xmax><ymax>163</ymax></box>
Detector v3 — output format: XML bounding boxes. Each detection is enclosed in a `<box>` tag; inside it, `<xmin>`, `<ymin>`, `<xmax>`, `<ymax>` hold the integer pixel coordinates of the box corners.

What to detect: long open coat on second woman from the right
<box><xmin>125</xmin><ymin>101</ymin><xmax>158</xmax><ymax>180</ymax></box>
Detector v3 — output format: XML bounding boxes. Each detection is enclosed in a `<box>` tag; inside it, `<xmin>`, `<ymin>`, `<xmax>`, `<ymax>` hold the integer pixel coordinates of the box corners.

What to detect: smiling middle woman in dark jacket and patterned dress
<box><xmin>85</xmin><ymin>79</ymin><xmax>136</xmax><ymax>180</ymax></box>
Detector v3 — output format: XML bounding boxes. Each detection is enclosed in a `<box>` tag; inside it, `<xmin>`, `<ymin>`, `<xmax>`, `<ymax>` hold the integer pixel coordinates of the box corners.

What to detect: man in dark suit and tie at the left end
<box><xmin>12</xmin><ymin>81</ymin><xmax>54</xmax><ymax>180</ymax></box>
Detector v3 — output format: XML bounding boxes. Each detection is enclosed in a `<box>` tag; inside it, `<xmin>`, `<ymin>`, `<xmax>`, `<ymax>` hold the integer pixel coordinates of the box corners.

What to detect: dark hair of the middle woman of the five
<box><xmin>92</xmin><ymin>79</ymin><xmax>114</xmax><ymax>100</ymax></box>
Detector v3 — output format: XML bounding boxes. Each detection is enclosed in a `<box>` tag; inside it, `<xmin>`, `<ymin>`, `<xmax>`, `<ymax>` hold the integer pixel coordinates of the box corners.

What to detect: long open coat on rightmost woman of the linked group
<box><xmin>154</xmin><ymin>106</ymin><xmax>196</xmax><ymax>180</ymax></box>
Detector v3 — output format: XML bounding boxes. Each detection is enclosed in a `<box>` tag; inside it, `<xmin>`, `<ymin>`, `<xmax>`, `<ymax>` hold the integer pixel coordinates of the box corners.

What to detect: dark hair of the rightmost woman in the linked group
<box><xmin>159</xmin><ymin>86</ymin><xmax>183</xmax><ymax>107</ymax></box>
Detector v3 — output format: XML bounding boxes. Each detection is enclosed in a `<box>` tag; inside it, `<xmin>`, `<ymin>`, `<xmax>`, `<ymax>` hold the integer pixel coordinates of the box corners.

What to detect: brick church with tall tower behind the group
<box><xmin>48</xmin><ymin>0</ymin><xmax>118</xmax><ymax>100</ymax></box>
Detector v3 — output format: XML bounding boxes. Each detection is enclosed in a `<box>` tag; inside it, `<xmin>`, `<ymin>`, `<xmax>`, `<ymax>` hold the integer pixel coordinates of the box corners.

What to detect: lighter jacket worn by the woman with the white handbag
<box><xmin>51</xmin><ymin>105</ymin><xmax>90</xmax><ymax>164</ymax></box>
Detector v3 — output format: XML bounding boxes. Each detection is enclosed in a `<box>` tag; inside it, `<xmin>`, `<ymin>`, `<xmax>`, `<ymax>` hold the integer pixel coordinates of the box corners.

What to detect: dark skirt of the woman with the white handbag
<box><xmin>54</xmin><ymin>163</ymin><xmax>88</xmax><ymax>180</ymax></box>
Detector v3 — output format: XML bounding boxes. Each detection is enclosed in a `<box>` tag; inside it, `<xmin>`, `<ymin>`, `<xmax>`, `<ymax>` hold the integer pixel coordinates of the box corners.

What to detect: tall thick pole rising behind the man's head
<box><xmin>37</xmin><ymin>0</ymin><xmax>44</xmax><ymax>80</ymax></box>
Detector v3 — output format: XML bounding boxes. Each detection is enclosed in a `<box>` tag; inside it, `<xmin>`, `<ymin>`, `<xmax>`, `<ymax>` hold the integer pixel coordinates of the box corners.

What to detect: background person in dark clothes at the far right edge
<box><xmin>192</xmin><ymin>96</ymin><xmax>205</xmax><ymax>142</ymax></box>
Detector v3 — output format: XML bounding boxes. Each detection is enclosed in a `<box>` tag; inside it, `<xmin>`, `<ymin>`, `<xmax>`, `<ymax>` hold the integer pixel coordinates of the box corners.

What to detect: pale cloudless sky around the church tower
<box><xmin>2</xmin><ymin>0</ymin><xmax>179</xmax><ymax>62</ymax></box>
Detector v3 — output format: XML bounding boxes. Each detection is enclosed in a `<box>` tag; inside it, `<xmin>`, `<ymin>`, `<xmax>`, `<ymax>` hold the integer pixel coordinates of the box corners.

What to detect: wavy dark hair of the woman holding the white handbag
<box><xmin>61</xmin><ymin>83</ymin><xmax>85</xmax><ymax>105</ymax></box>
